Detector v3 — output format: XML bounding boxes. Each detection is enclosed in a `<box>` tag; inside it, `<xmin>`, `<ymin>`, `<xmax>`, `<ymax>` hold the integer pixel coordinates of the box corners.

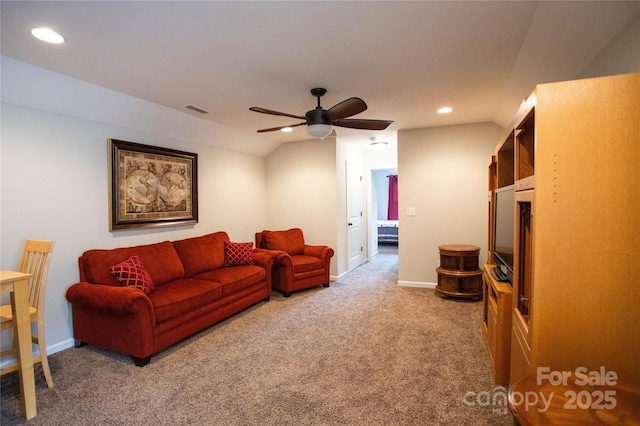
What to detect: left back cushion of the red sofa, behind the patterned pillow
<box><xmin>78</xmin><ymin>241</ymin><xmax>184</xmax><ymax>286</ymax></box>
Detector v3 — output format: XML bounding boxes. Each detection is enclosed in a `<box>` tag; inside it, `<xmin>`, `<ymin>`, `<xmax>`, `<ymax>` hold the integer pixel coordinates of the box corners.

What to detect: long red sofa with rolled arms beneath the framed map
<box><xmin>67</xmin><ymin>232</ymin><xmax>273</xmax><ymax>366</ymax></box>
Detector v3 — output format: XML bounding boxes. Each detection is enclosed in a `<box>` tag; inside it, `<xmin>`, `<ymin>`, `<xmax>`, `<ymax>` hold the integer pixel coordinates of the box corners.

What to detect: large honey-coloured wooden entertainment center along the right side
<box><xmin>482</xmin><ymin>73</ymin><xmax>640</xmax><ymax>385</ymax></box>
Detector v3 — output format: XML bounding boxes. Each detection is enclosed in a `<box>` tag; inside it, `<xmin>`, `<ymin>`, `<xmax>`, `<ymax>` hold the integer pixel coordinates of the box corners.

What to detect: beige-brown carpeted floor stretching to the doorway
<box><xmin>0</xmin><ymin>250</ymin><xmax>511</xmax><ymax>425</ymax></box>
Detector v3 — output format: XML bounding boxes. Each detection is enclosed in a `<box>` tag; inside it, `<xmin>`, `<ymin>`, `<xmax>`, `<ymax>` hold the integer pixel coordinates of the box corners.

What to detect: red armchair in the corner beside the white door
<box><xmin>256</xmin><ymin>228</ymin><xmax>334</xmax><ymax>297</ymax></box>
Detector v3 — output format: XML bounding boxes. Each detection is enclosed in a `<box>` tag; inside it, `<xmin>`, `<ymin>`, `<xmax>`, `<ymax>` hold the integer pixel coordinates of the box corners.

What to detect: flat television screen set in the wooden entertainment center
<box><xmin>493</xmin><ymin>185</ymin><xmax>515</xmax><ymax>282</ymax></box>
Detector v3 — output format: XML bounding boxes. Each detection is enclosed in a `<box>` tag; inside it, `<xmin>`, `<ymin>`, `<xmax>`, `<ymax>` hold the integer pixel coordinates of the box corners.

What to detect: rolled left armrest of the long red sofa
<box><xmin>67</xmin><ymin>282</ymin><xmax>155</xmax><ymax>325</ymax></box>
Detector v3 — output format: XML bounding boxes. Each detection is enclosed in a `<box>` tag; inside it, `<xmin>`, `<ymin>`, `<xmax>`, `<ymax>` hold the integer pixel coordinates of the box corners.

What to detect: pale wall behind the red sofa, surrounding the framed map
<box><xmin>0</xmin><ymin>86</ymin><xmax>267</xmax><ymax>353</ymax></box>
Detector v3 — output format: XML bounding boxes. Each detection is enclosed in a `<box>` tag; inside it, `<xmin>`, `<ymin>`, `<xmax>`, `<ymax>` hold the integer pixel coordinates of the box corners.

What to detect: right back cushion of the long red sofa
<box><xmin>173</xmin><ymin>232</ymin><xmax>229</xmax><ymax>277</ymax></box>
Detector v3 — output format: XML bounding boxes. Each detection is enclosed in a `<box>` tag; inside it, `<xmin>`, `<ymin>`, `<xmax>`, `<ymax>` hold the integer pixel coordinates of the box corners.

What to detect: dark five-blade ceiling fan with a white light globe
<box><xmin>249</xmin><ymin>87</ymin><xmax>393</xmax><ymax>139</ymax></box>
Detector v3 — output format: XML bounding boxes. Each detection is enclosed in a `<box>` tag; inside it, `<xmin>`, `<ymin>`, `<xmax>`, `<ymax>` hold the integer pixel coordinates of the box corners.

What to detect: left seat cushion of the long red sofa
<box><xmin>149</xmin><ymin>278</ymin><xmax>222</xmax><ymax>322</ymax></box>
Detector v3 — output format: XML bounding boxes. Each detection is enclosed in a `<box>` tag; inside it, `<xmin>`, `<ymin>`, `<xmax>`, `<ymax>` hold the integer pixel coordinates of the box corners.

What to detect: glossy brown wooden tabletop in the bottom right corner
<box><xmin>509</xmin><ymin>372</ymin><xmax>640</xmax><ymax>426</ymax></box>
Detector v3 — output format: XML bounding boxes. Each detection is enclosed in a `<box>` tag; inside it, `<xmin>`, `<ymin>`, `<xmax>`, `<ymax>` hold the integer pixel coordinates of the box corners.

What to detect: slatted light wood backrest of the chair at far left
<box><xmin>20</xmin><ymin>240</ymin><xmax>55</xmax><ymax>310</ymax></box>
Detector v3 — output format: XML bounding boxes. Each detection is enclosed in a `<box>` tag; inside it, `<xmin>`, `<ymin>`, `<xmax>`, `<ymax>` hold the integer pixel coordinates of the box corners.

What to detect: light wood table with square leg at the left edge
<box><xmin>0</xmin><ymin>271</ymin><xmax>36</xmax><ymax>420</ymax></box>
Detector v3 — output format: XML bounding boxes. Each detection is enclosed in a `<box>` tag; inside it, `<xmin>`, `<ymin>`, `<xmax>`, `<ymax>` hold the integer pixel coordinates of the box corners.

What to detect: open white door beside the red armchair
<box><xmin>347</xmin><ymin>163</ymin><xmax>364</xmax><ymax>271</ymax></box>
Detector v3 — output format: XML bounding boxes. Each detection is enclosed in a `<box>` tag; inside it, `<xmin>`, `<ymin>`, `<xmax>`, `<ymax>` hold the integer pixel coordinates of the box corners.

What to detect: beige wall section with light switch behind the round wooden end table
<box><xmin>398</xmin><ymin>123</ymin><xmax>504</xmax><ymax>286</ymax></box>
